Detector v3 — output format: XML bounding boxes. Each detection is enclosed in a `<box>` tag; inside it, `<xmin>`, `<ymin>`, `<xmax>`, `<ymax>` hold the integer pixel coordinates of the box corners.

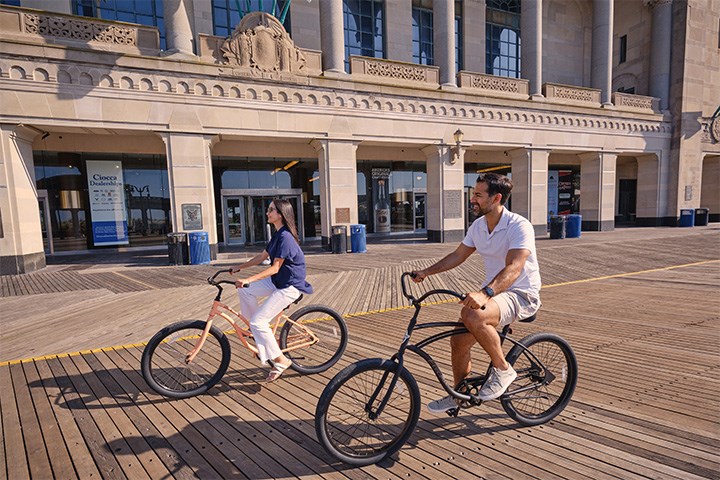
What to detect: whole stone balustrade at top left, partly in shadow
<box><xmin>0</xmin><ymin>7</ymin><xmax>160</xmax><ymax>56</ymax></box>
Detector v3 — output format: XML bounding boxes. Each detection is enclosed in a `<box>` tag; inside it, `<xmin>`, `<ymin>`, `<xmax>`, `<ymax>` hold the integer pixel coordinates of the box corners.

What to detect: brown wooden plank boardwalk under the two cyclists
<box><xmin>0</xmin><ymin>227</ymin><xmax>720</xmax><ymax>479</ymax></box>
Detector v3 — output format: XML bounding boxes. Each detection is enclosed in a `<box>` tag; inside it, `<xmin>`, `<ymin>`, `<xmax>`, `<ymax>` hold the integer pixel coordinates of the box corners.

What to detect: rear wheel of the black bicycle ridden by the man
<box><xmin>500</xmin><ymin>333</ymin><xmax>578</xmax><ymax>426</ymax></box>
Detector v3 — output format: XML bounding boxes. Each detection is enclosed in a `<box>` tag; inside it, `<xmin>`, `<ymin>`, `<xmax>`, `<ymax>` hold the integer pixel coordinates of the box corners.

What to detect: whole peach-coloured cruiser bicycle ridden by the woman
<box><xmin>141</xmin><ymin>270</ymin><xmax>348</xmax><ymax>398</ymax></box>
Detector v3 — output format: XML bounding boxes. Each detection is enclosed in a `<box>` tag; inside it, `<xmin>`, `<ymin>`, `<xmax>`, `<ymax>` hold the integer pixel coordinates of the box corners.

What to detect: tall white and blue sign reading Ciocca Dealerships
<box><xmin>87</xmin><ymin>160</ymin><xmax>130</xmax><ymax>246</ymax></box>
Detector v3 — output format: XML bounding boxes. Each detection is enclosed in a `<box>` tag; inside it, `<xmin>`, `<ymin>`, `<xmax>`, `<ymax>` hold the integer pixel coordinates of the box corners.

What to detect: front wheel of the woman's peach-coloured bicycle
<box><xmin>141</xmin><ymin>320</ymin><xmax>230</xmax><ymax>398</ymax></box>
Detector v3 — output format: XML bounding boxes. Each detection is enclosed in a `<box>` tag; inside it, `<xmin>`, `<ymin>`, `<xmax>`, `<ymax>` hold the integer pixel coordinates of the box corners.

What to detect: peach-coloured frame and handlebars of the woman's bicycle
<box><xmin>185</xmin><ymin>270</ymin><xmax>318</xmax><ymax>363</ymax></box>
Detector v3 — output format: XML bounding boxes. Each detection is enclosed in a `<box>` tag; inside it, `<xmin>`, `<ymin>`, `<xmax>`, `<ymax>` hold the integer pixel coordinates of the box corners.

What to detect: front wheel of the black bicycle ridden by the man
<box><xmin>315</xmin><ymin>358</ymin><xmax>421</xmax><ymax>466</ymax></box>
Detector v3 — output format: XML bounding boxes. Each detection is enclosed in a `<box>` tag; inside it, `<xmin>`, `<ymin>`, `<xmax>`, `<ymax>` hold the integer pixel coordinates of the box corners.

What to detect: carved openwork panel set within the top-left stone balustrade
<box><xmin>23</xmin><ymin>13</ymin><xmax>137</xmax><ymax>46</ymax></box>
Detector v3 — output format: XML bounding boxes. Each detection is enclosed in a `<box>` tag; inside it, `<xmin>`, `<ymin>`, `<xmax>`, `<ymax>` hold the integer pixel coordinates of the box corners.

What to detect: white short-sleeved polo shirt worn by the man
<box><xmin>463</xmin><ymin>208</ymin><xmax>541</xmax><ymax>298</ymax></box>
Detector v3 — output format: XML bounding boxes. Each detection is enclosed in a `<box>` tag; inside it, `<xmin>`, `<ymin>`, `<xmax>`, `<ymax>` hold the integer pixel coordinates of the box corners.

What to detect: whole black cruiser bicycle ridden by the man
<box><xmin>315</xmin><ymin>272</ymin><xmax>578</xmax><ymax>466</ymax></box>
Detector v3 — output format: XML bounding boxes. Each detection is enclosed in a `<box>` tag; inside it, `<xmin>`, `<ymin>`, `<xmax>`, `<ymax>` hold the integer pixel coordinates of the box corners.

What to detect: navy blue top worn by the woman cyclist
<box><xmin>265</xmin><ymin>226</ymin><xmax>313</xmax><ymax>293</ymax></box>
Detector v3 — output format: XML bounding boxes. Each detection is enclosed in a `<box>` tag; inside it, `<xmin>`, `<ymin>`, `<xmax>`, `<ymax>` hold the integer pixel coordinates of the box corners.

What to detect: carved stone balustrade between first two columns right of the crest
<box><xmin>350</xmin><ymin>56</ymin><xmax>440</xmax><ymax>88</ymax></box>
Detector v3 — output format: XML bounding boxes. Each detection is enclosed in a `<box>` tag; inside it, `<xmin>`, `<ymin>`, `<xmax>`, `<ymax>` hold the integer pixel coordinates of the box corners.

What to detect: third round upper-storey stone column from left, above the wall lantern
<box><xmin>433</xmin><ymin>0</ymin><xmax>457</xmax><ymax>87</ymax></box>
